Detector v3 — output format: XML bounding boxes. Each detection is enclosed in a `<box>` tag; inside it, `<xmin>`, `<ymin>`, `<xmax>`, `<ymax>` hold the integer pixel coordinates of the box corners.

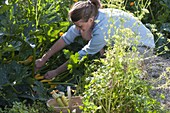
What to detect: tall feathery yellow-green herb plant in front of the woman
<box><xmin>82</xmin><ymin>22</ymin><xmax>162</xmax><ymax>113</ymax></box>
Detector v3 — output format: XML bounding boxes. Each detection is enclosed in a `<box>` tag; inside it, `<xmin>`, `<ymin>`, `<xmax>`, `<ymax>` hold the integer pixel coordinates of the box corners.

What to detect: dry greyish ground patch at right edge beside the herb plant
<box><xmin>144</xmin><ymin>56</ymin><xmax>170</xmax><ymax>110</ymax></box>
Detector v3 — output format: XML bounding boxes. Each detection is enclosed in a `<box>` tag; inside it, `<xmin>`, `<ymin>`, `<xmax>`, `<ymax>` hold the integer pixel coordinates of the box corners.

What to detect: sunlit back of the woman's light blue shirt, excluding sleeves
<box><xmin>96</xmin><ymin>8</ymin><xmax>155</xmax><ymax>48</ymax></box>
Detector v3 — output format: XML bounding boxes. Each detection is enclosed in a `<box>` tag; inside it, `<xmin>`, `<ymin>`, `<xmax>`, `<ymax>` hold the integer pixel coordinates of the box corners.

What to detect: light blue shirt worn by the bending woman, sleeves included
<box><xmin>62</xmin><ymin>8</ymin><xmax>155</xmax><ymax>57</ymax></box>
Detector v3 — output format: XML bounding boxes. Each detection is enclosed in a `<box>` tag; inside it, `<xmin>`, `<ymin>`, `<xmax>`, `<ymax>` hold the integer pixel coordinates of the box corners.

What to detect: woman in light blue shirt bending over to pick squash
<box><xmin>36</xmin><ymin>0</ymin><xmax>155</xmax><ymax>79</ymax></box>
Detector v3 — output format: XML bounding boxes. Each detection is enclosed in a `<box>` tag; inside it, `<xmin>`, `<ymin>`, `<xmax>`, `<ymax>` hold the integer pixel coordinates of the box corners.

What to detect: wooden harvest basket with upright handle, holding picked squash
<box><xmin>47</xmin><ymin>88</ymin><xmax>82</xmax><ymax>113</ymax></box>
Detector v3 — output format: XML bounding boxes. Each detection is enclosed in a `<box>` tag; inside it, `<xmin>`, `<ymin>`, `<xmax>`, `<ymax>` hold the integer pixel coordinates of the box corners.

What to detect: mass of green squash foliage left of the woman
<box><xmin>0</xmin><ymin>0</ymin><xmax>72</xmax><ymax>107</ymax></box>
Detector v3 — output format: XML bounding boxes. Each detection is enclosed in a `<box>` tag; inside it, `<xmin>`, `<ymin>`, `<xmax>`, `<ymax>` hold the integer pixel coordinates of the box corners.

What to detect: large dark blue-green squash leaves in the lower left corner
<box><xmin>0</xmin><ymin>61</ymin><xmax>48</xmax><ymax>106</ymax></box>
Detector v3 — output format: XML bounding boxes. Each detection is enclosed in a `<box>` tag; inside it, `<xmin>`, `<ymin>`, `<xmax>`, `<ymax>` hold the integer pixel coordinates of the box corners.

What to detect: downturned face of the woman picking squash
<box><xmin>74</xmin><ymin>18</ymin><xmax>94</xmax><ymax>32</ymax></box>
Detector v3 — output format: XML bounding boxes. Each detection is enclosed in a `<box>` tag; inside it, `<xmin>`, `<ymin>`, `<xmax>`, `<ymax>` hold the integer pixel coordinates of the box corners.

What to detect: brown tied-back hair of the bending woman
<box><xmin>69</xmin><ymin>0</ymin><xmax>101</xmax><ymax>22</ymax></box>
